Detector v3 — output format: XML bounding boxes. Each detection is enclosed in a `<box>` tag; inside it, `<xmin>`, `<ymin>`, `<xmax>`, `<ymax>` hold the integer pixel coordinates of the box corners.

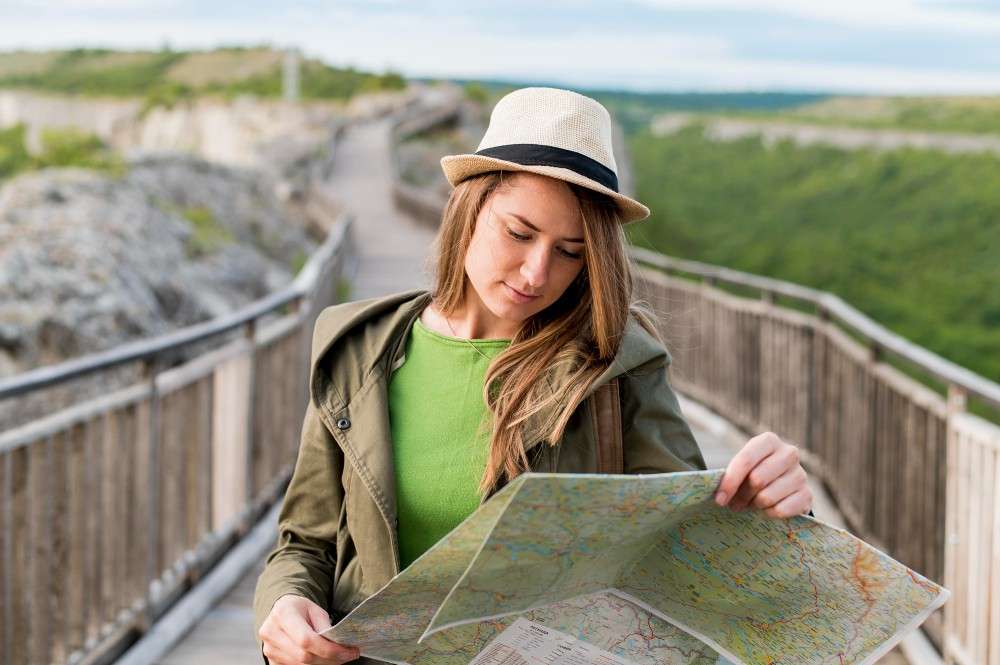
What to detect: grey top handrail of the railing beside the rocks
<box><xmin>0</xmin><ymin>214</ymin><xmax>353</xmax><ymax>399</ymax></box>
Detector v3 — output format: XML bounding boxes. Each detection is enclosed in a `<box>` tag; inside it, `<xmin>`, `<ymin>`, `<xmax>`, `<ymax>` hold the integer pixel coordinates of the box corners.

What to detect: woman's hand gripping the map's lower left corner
<box><xmin>257</xmin><ymin>594</ymin><xmax>361</xmax><ymax>665</ymax></box>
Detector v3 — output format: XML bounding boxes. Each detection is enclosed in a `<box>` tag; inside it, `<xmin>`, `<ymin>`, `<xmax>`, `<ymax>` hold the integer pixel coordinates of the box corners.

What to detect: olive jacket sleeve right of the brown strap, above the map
<box><xmin>620</xmin><ymin>356</ymin><xmax>705</xmax><ymax>473</ymax></box>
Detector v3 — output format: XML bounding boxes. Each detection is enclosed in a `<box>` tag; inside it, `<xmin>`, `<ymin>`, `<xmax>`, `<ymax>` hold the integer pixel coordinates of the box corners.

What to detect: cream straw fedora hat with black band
<box><xmin>441</xmin><ymin>87</ymin><xmax>649</xmax><ymax>224</ymax></box>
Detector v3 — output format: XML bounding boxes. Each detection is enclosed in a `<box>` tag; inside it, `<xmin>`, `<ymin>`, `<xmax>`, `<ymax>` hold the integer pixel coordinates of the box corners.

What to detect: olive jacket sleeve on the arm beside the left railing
<box><xmin>253</xmin><ymin>400</ymin><xmax>344</xmax><ymax>663</ymax></box>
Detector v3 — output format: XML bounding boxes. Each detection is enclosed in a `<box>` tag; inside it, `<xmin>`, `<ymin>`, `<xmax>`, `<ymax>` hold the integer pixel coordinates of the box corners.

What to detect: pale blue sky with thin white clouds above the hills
<box><xmin>0</xmin><ymin>0</ymin><xmax>1000</xmax><ymax>94</ymax></box>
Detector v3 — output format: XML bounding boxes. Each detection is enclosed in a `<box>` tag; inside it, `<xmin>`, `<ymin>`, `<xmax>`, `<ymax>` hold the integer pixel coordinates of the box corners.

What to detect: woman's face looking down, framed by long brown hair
<box><xmin>465</xmin><ymin>172</ymin><xmax>584</xmax><ymax>331</ymax></box>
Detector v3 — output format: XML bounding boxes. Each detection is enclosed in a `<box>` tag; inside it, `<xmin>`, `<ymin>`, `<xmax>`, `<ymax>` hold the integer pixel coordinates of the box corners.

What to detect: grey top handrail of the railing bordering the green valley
<box><xmin>630</xmin><ymin>247</ymin><xmax>1000</xmax><ymax>408</ymax></box>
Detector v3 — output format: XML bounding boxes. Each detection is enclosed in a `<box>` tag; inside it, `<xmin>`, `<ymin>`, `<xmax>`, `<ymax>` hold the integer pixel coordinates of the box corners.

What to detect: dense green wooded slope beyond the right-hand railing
<box><xmin>629</xmin><ymin>126</ymin><xmax>1000</xmax><ymax>390</ymax></box>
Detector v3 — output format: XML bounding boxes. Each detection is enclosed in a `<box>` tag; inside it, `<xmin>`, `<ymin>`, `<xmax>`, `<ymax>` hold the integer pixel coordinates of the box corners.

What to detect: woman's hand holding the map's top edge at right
<box><xmin>715</xmin><ymin>432</ymin><xmax>812</xmax><ymax>518</ymax></box>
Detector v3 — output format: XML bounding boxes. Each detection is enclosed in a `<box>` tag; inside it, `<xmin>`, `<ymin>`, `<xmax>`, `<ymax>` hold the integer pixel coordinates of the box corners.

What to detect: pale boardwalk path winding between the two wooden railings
<box><xmin>152</xmin><ymin>120</ymin><xmax>864</xmax><ymax>665</ymax></box>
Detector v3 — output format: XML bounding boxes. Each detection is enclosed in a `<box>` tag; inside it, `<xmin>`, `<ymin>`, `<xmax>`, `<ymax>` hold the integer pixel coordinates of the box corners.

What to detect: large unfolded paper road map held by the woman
<box><xmin>323</xmin><ymin>469</ymin><xmax>948</xmax><ymax>665</ymax></box>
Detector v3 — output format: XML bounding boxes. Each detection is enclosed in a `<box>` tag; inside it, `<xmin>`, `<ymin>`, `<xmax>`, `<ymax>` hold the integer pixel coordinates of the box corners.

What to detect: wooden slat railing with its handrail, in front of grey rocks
<box><xmin>0</xmin><ymin>216</ymin><xmax>355</xmax><ymax>664</ymax></box>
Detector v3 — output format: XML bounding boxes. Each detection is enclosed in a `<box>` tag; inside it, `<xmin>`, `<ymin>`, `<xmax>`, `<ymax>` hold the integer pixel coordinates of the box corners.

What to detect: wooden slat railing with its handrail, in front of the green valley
<box><xmin>632</xmin><ymin>248</ymin><xmax>1000</xmax><ymax>665</ymax></box>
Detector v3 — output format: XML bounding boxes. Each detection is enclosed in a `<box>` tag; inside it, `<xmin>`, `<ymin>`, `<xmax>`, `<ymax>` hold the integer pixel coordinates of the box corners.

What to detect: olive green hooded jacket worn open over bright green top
<box><xmin>254</xmin><ymin>290</ymin><xmax>705</xmax><ymax>662</ymax></box>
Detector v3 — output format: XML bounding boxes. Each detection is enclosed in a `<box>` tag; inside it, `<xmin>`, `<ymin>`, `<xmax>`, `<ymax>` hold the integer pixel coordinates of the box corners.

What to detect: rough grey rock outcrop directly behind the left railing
<box><xmin>0</xmin><ymin>155</ymin><xmax>318</xmax><ymax>376</ymax></box>
